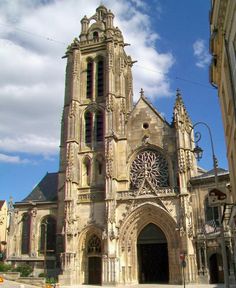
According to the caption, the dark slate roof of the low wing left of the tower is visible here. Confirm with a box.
[21,173,58,202]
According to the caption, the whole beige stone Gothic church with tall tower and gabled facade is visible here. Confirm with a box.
[7,5,232,285]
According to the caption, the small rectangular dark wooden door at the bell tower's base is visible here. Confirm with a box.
[88,257,102,285]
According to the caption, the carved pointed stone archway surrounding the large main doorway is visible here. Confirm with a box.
[119,202,182,284]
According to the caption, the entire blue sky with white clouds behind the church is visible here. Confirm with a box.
[0,0,227,201]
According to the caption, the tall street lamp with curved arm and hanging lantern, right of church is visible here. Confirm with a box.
[190,122,229,288]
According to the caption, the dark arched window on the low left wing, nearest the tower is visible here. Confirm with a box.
[40,216,56,254]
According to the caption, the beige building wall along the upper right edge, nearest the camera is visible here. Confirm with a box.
[210,0,236,202]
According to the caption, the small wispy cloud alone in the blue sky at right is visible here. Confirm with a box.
[193,39,211,68]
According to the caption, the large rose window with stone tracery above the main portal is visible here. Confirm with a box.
[130,150,169,189]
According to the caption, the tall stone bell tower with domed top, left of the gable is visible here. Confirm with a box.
[57,5,133,284]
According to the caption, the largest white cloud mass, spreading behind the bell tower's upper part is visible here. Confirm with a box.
[0,0,174,158]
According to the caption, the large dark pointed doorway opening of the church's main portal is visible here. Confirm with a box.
[137,223,169,284]
